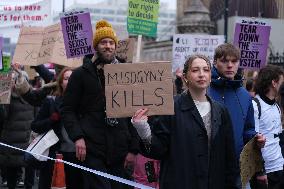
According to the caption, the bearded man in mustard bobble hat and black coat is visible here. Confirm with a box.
[62,20,139,189]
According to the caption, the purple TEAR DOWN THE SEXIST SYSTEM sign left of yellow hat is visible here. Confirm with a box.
[60,12,95,58]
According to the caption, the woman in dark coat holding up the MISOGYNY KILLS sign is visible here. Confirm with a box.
[132,55,237,189]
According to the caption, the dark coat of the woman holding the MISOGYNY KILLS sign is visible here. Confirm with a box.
[141,91,237,189]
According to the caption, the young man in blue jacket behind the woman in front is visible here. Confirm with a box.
[208,43,265,188]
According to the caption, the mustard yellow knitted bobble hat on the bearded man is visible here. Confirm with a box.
[93,20,118,47]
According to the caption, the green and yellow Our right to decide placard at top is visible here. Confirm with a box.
[127,0,160,37]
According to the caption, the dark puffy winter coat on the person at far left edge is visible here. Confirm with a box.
[0,96,34,167]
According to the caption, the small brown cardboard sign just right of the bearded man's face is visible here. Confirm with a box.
[116,38,136,63]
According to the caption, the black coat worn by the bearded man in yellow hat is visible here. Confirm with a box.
[62,57,139,164]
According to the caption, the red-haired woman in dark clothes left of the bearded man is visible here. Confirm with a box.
[31,68,82,189]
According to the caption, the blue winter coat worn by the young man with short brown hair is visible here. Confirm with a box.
[208,67,256,157]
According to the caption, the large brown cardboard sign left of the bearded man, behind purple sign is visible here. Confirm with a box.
[13,24,82,67]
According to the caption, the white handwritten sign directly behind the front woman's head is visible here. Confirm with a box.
[172,34,225,72]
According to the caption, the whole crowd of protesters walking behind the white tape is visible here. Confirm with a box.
[0,20,284,189]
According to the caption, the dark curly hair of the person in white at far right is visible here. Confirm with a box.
[254,65,284,95]
